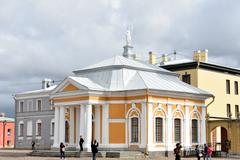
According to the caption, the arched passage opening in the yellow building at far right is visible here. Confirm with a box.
[211,126,228,152]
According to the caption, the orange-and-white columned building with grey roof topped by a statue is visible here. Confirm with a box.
[13,33,212,156]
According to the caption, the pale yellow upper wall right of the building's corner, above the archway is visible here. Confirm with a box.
[198,69,240,118]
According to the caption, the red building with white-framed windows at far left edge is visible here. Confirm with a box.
[0,113,14,148]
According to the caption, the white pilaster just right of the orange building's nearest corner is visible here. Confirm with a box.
[147,103,153,151]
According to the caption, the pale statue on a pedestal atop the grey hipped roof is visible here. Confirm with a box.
[123,27,136,59]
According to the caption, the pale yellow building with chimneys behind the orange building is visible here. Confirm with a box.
[161,50,240,153]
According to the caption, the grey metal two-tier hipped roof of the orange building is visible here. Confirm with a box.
[69,56,211,96]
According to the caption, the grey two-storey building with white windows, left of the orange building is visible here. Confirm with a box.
[14,83,55,149]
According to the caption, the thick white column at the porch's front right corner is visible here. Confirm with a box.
[85,104,92,152]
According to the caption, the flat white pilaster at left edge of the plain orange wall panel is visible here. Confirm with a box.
[102,104,109,147]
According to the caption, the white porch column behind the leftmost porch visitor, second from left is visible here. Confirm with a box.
[59,106,65,143]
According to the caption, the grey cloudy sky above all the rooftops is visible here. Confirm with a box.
[0,0,240,116]
